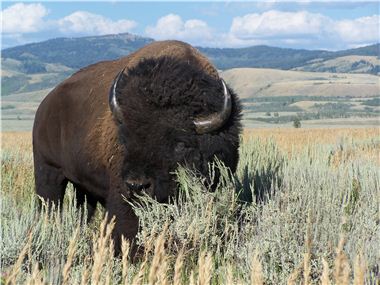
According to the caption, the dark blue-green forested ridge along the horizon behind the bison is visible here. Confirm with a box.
[2,33,380,73]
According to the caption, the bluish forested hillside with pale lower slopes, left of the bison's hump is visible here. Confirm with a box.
[1,33,153,96]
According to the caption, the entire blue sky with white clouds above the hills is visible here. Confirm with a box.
[1,1,380,50]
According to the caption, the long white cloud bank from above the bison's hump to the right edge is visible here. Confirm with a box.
[145,10,380,49]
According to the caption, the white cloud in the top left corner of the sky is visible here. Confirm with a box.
[0,3,49,34]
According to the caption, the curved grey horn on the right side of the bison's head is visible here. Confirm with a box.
[194,79,232,134]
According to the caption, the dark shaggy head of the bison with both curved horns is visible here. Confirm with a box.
[110,57,241,202]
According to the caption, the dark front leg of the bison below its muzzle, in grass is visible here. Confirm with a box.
[106,189,139,257]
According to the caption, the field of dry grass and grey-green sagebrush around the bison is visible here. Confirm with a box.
[0,128,380,284]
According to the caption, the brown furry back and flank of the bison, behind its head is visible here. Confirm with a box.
[33,38,217,186]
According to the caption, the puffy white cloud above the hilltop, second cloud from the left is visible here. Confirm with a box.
[58,11,137,35]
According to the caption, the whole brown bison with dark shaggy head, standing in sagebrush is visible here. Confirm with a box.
[33,41,241,251]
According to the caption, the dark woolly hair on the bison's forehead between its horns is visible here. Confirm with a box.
[114,56,241,134]
